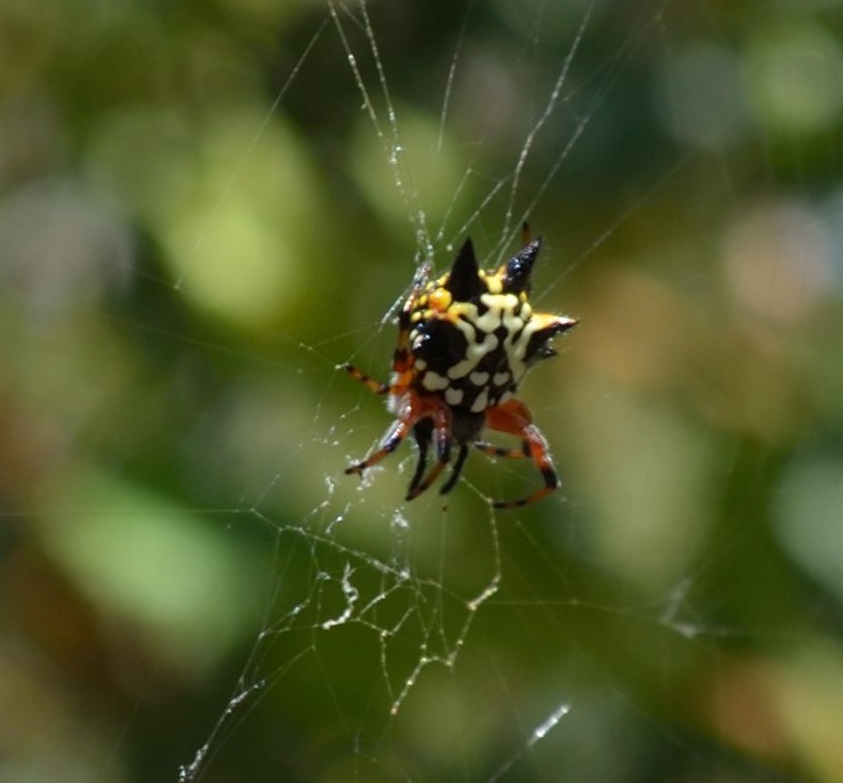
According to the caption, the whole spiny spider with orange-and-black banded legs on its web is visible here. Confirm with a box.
[342,223,577,509]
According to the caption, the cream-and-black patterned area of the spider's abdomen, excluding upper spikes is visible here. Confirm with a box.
[410,293,556,413]
